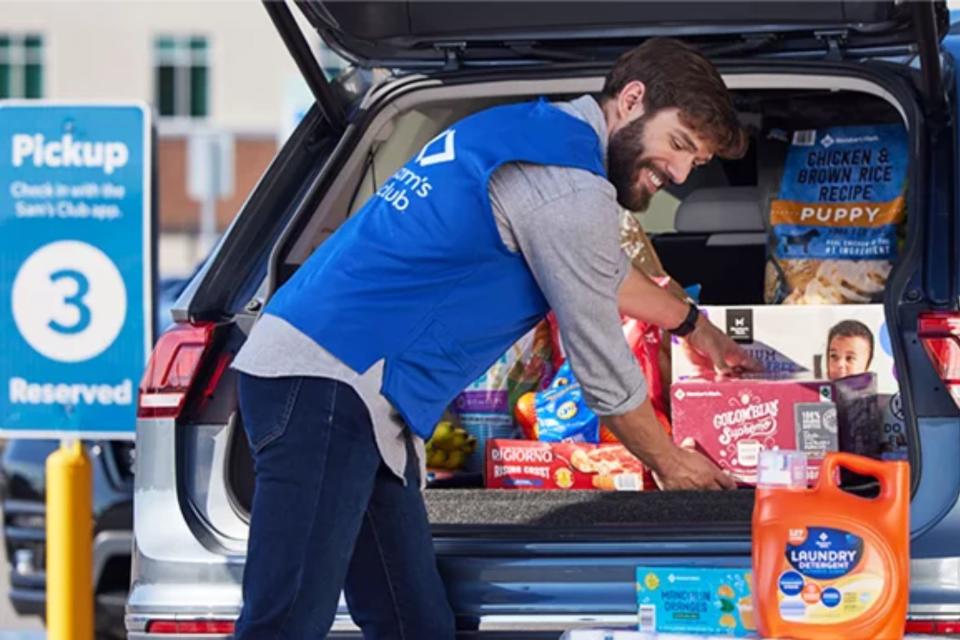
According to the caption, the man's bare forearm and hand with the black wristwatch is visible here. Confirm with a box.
[619,267,763,373]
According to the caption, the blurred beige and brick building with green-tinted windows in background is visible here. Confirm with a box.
[0,0,343,276]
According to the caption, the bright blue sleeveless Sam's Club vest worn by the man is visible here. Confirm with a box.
[265,100,605,438]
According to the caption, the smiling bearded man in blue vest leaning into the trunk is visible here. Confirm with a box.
[233,39,756,640]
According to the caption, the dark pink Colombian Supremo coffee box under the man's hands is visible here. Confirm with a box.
[671,378,838,484]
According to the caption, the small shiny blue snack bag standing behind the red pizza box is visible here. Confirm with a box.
[536,362,600,443]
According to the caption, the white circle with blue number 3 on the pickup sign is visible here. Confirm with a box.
[13,240,127,362]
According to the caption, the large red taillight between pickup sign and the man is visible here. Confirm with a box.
[137,323,213,418]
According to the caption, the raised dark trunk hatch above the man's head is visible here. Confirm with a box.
[297,0,949,68]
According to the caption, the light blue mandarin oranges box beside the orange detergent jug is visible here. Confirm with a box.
[637,567,757,637]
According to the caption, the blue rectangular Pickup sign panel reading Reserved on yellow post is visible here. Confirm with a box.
[0,101,153,438]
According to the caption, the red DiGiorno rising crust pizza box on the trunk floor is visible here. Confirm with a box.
[484,440,652,491]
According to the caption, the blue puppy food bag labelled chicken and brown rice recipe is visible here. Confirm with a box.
[765,125,908,304]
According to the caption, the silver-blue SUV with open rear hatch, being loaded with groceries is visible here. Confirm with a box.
[126,0,960,640]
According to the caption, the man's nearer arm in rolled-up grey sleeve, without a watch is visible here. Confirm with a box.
[491,168,733,489]
